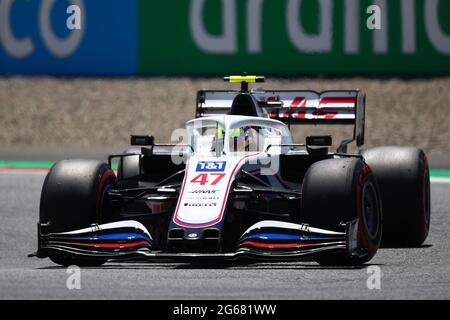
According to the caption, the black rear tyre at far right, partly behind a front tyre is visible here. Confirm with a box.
[361,146,430,247]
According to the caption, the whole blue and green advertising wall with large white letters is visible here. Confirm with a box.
[0,0,450,76]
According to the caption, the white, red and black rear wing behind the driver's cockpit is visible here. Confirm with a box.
[196,90,365,146]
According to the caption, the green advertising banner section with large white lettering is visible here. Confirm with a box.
[139,0,450,75]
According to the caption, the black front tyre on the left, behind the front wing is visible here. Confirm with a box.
[39,160,117,266]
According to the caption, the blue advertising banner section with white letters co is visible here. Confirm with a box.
[0,0,137,75]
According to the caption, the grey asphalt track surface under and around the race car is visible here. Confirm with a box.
[0,172,450,299]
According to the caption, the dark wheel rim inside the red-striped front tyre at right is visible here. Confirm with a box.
[362,182,380,239]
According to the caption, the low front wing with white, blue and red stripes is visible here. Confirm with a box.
[30,220,366,261]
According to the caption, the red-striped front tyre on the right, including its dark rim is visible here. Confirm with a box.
[301,158,382,265]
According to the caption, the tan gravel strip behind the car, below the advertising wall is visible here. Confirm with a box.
[0,77,450,155]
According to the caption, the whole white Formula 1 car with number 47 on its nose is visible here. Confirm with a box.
[32,76,430,265]
